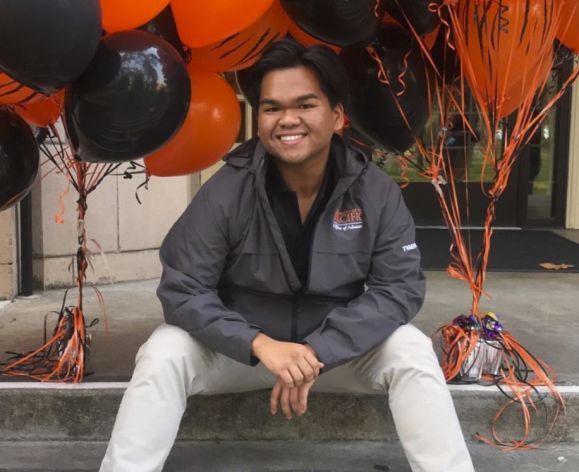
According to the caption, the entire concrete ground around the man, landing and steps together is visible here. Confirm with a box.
[0,272,579,472]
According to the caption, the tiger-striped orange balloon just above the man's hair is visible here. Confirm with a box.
[190,1,290,72]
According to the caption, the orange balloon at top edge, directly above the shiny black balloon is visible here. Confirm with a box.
[101,0,169,33]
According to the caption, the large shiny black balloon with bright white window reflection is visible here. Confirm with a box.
[65,30,191,162]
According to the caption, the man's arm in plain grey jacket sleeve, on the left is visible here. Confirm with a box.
[157,184,260,365]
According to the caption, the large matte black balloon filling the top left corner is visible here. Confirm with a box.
[0,0,102,94]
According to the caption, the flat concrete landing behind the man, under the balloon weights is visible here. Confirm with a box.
[0,272,579,385]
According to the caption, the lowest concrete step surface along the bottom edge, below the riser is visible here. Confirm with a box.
[0,441,579,472]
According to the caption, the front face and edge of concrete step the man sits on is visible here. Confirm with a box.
[0,382,579,444]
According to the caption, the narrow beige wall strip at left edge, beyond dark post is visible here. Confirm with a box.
[0,208,18,300]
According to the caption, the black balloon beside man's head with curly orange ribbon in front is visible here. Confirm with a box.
[340,27,429,153]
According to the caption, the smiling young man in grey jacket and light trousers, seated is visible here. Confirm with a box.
[101,41,473,472]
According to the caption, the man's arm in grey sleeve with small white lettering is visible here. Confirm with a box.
[305,183,426,370]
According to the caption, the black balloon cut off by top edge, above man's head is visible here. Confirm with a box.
[281,0,384,47]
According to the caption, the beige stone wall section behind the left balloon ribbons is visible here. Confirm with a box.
[32,163,199,289]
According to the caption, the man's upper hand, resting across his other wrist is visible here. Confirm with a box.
[251,333,324,388]
